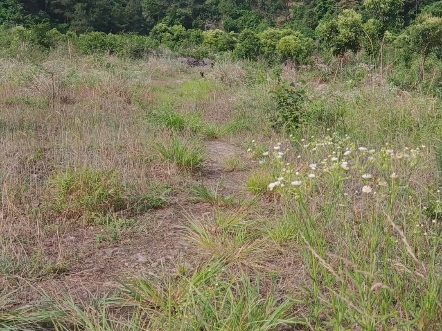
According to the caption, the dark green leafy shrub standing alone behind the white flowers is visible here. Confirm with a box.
[271,83,307,132]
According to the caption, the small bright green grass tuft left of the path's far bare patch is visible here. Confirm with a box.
[158,137,205,170]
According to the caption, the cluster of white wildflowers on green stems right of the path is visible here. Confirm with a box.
[248,135,424,194]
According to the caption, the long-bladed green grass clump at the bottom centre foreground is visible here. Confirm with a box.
[121,263,301,331]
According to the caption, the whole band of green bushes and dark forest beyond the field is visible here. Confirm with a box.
[0,0,442,95]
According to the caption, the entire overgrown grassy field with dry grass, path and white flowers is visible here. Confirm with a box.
[0,52,442,331]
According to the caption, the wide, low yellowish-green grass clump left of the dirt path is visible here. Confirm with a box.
[49,168,126,219]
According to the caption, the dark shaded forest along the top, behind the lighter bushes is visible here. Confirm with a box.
[0,0,442,35]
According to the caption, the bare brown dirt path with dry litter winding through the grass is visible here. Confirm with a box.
[33,140,250,301]
